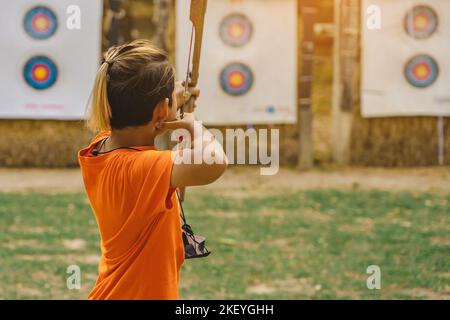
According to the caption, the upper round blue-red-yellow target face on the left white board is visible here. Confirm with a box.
[24,6,58,40]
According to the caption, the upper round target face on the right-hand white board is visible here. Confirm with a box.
[405,6,438,39]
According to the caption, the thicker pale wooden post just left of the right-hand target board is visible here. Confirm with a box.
[333,0,361,165]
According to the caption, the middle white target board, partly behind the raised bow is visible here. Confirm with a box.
[175,0,298,126]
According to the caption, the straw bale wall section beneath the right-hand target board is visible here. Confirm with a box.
[350,109,450,167]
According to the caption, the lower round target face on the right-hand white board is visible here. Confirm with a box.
[405,55,439,88]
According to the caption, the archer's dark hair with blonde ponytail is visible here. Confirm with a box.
[87,40,175,132]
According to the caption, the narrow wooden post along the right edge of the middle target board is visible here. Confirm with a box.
[298,1,317,170]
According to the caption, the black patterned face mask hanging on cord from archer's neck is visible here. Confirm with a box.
[92,138,211,259]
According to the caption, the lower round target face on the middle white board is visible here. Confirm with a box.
[220,63,253,96]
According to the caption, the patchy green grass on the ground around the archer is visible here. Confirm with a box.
[0,190,450,299]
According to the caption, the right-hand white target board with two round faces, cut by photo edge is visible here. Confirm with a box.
[361,0,450,117]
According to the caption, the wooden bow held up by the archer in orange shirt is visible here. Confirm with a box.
[180,0,208,201]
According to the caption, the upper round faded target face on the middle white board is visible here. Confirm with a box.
[220,14,253,47]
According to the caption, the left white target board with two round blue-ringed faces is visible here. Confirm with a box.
[0,0,103,120]
